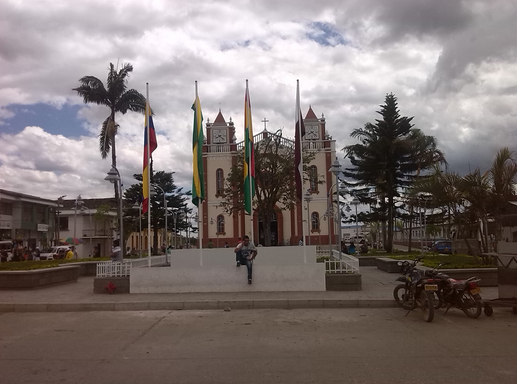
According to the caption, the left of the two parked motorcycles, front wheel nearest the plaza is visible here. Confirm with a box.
[393,258,438,322]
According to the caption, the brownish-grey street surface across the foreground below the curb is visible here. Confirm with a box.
[0,308,517,384]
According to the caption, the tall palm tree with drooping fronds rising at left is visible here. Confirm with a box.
[73,63,146,198]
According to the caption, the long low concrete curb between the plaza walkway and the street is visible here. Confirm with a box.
[0,299,397,313]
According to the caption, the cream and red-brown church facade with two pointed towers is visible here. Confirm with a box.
[200,107,338,248]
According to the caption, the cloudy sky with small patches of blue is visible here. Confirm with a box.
[0,0,517,199]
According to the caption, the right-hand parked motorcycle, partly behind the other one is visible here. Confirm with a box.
[425,264,483,319]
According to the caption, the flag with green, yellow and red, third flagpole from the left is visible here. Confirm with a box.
[244,80,255,215]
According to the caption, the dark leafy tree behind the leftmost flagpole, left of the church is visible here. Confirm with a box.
[124,171,188,250]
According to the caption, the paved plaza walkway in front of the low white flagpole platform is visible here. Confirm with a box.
[0,267,498,312]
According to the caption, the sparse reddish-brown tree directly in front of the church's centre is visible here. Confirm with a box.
[221,131,316,246]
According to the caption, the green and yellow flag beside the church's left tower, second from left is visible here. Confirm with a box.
[192,92,205,207]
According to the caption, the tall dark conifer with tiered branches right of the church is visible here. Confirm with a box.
[343,94,443,252]
